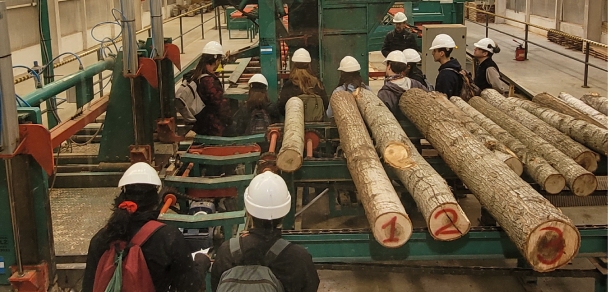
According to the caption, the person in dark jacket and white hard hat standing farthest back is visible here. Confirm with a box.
[381,12,419,57]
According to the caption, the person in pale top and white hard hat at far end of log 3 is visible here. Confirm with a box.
[377,51,428,119]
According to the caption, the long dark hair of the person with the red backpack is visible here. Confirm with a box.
[102,184,160,244]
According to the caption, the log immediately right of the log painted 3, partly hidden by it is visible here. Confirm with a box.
[430,91,523,175]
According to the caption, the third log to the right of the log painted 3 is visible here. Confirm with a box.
[468,96,597,196]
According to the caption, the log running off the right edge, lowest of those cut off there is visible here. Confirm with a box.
[508,97,608,155]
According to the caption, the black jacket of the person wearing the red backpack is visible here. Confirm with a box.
[82,212,210,292]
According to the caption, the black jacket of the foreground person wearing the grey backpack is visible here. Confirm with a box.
[212,228,320,292]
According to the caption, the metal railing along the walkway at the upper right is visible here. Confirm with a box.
[467,8,608,88]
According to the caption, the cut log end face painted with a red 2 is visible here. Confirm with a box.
[428,202,470,241]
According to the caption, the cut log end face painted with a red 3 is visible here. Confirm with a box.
[525,221,580,272]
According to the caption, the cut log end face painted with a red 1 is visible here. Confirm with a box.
[373,212,413,248]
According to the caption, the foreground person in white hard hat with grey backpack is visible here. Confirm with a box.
[212,171,320,292]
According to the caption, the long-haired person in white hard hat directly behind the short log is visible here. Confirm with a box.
[277,48,328,118]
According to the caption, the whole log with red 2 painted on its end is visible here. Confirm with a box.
[354,90,470,241]
